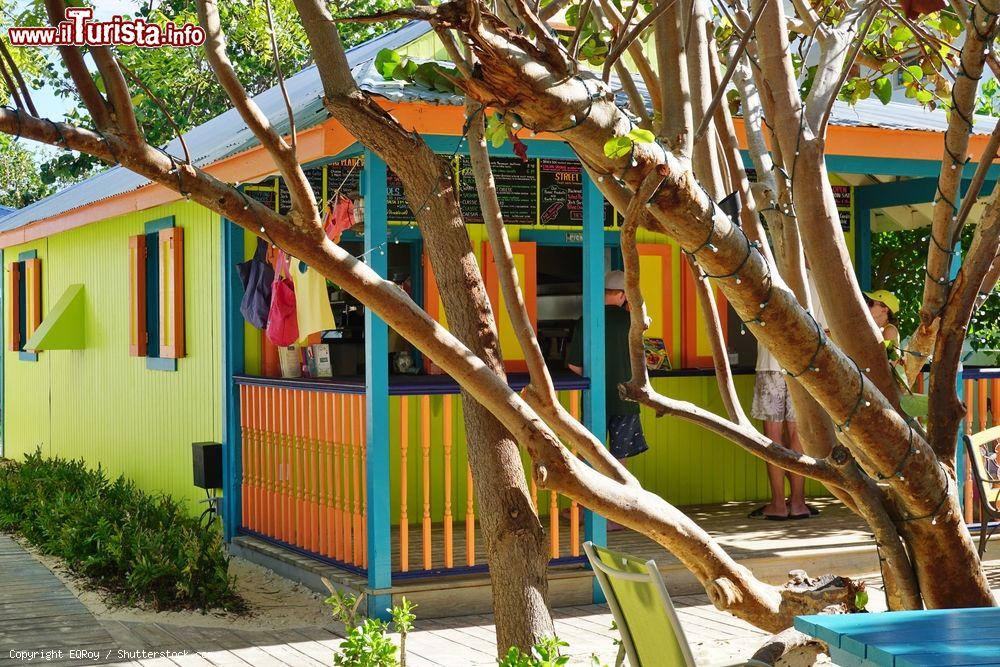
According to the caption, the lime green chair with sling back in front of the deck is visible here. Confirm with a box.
[583,542,764,667]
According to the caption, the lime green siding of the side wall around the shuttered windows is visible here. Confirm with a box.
[3,202,222,511]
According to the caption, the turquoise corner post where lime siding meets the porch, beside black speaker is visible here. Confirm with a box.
[222,218,245,542]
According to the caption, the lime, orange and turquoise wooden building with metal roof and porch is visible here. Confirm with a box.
[0,24,1000,614]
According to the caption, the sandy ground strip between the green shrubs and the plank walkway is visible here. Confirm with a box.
[14,536,333,630]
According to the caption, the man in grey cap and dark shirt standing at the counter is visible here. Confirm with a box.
[566,271,649,498]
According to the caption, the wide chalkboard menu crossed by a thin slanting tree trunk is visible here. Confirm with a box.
[458,156,538,225]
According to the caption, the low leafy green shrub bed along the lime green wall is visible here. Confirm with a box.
[0,453,245,611]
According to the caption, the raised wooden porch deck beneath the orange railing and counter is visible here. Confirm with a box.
[232,499,878,618]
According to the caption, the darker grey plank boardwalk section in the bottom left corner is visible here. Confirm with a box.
[0,535,118,665]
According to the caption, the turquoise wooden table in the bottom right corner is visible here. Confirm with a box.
[795,607,1000,667]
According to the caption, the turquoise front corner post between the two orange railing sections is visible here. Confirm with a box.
[361,151,392,620]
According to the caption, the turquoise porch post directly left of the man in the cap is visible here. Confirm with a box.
[583,173,608,603]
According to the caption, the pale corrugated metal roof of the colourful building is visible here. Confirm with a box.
[0,22,996,232]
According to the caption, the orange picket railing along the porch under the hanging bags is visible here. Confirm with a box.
[238,378,581,576]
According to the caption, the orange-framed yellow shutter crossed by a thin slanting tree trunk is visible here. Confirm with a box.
[483,241,538,373]
